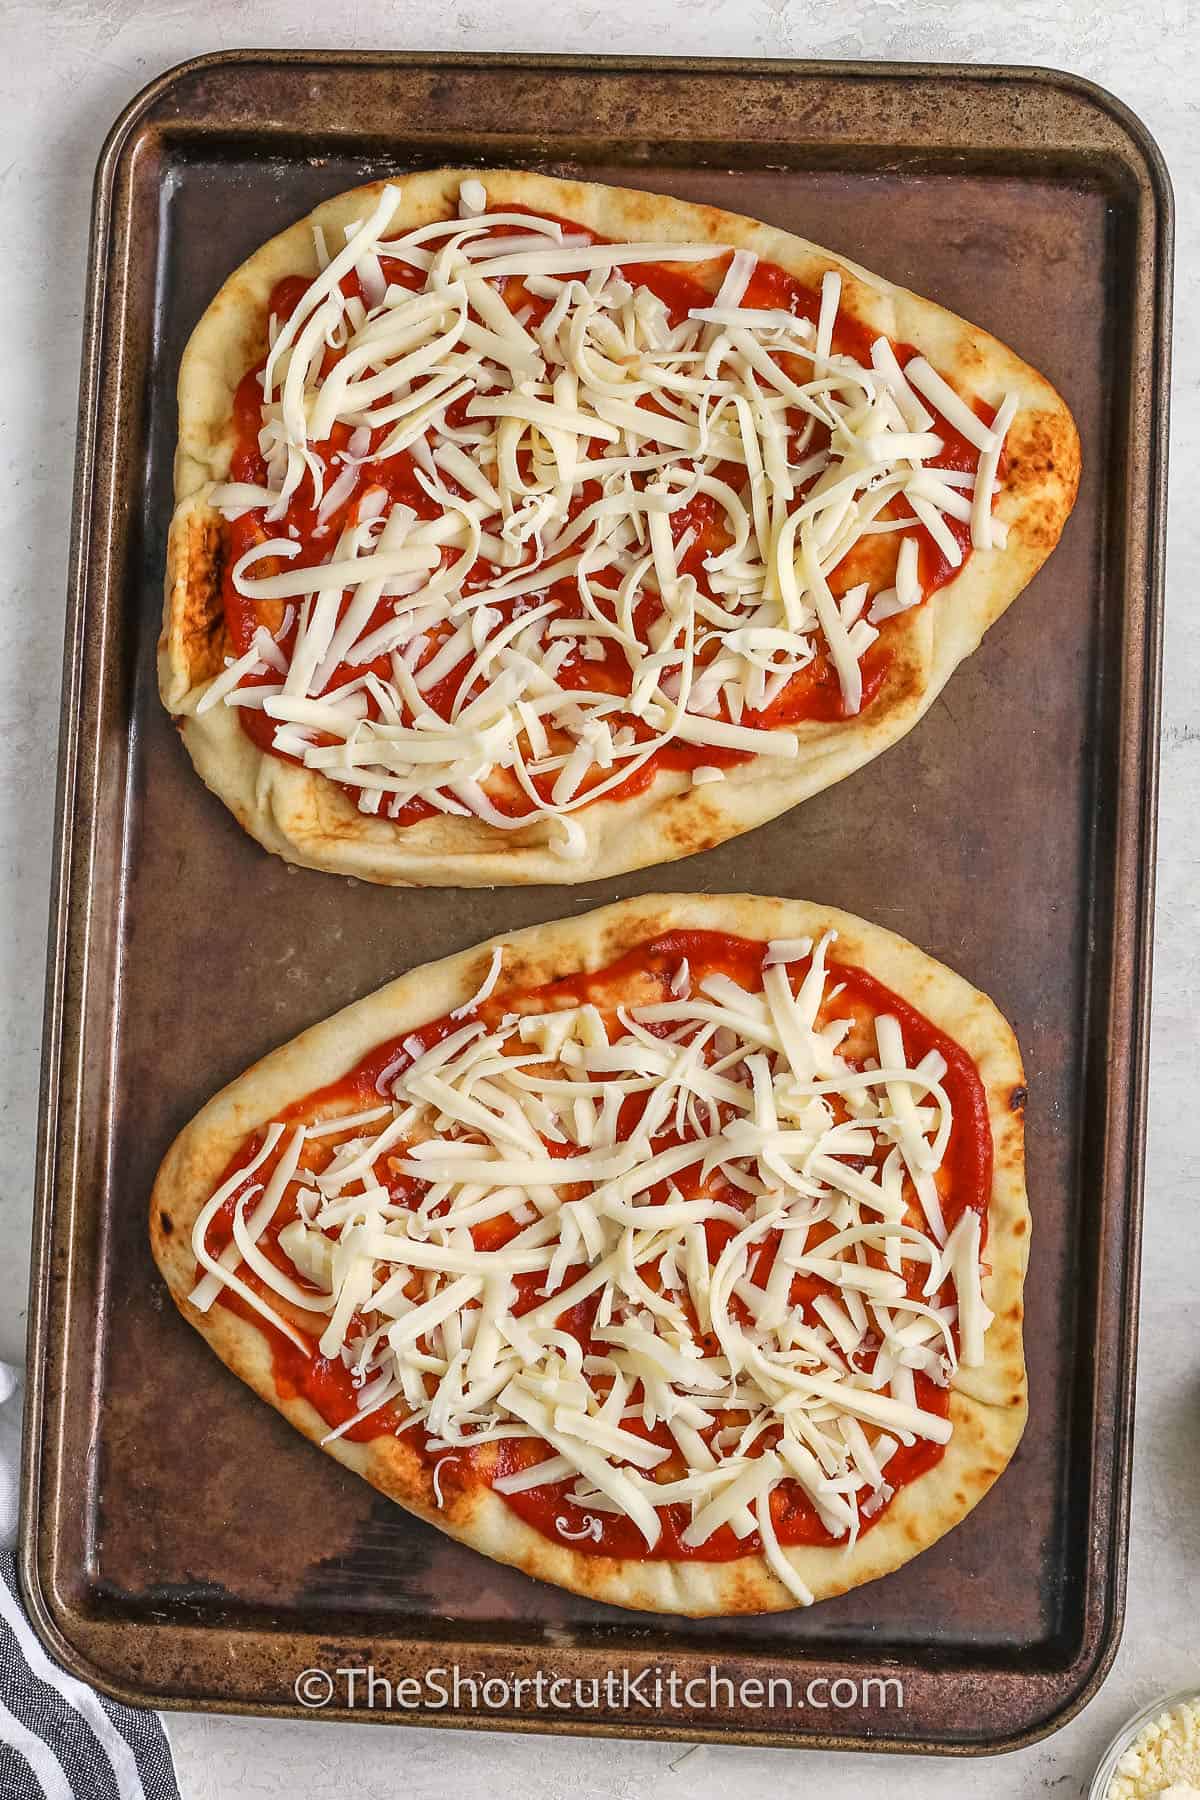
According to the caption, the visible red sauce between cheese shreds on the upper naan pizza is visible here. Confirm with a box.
[223,207,1006,826]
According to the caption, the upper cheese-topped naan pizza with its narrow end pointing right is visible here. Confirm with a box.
[160,171,1079,886]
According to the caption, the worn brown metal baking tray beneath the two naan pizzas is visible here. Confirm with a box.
[22,52,1171,1753]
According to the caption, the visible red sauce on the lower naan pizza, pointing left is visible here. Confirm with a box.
[207,931,991,1562]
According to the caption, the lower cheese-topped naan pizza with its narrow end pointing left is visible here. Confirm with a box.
[151,895,1029,1615]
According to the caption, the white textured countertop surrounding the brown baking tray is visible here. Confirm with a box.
[0,0,1200,1800]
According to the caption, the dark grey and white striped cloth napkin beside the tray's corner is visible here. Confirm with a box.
[0,1363,180,1800]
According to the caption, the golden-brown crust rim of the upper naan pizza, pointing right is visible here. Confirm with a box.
[158,169,1079,887]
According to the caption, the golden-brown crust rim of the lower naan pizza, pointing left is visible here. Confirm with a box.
[149,895,1031,1616]
